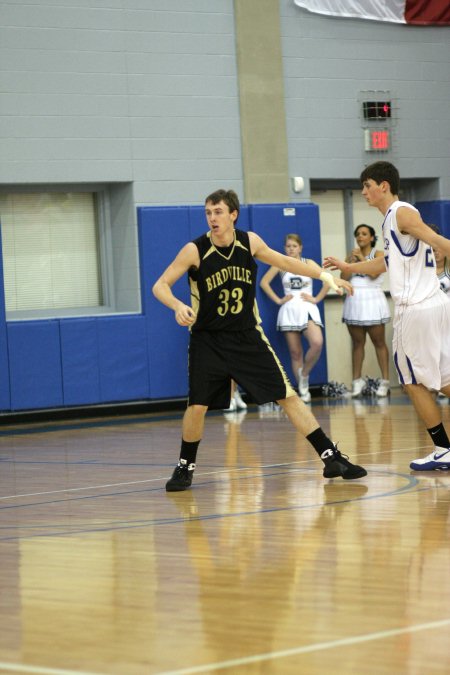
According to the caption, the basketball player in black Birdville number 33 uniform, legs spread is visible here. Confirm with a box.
[153,190,367,492]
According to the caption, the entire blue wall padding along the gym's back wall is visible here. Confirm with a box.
[0,201,450,411]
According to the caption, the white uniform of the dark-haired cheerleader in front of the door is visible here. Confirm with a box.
[342,248,391,326]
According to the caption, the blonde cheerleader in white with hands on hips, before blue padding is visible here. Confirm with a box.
[260,234,329,403]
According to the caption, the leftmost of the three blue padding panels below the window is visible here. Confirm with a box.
[7,320,64,410]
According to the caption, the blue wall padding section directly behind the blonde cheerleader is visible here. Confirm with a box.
[250,204,328,385]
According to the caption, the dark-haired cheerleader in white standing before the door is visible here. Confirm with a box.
[341,224,391,396]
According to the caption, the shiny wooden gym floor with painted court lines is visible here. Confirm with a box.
[0,392,450,675]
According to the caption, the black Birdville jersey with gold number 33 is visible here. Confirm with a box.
[189,230,260,331]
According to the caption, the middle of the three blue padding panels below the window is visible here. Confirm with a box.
[60,319,101,405]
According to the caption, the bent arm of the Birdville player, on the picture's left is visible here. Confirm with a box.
[152,242,200,326]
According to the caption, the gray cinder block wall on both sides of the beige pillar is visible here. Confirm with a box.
[0,0,450,204]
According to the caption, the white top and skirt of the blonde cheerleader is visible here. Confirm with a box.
[277,258,323,333]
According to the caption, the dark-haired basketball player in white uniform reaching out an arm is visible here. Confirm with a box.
[324,162,450,471]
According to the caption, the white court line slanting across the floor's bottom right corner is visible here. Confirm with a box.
[158,618,450,675]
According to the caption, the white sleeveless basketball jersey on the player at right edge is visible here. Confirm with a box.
[383,201,440,305]
